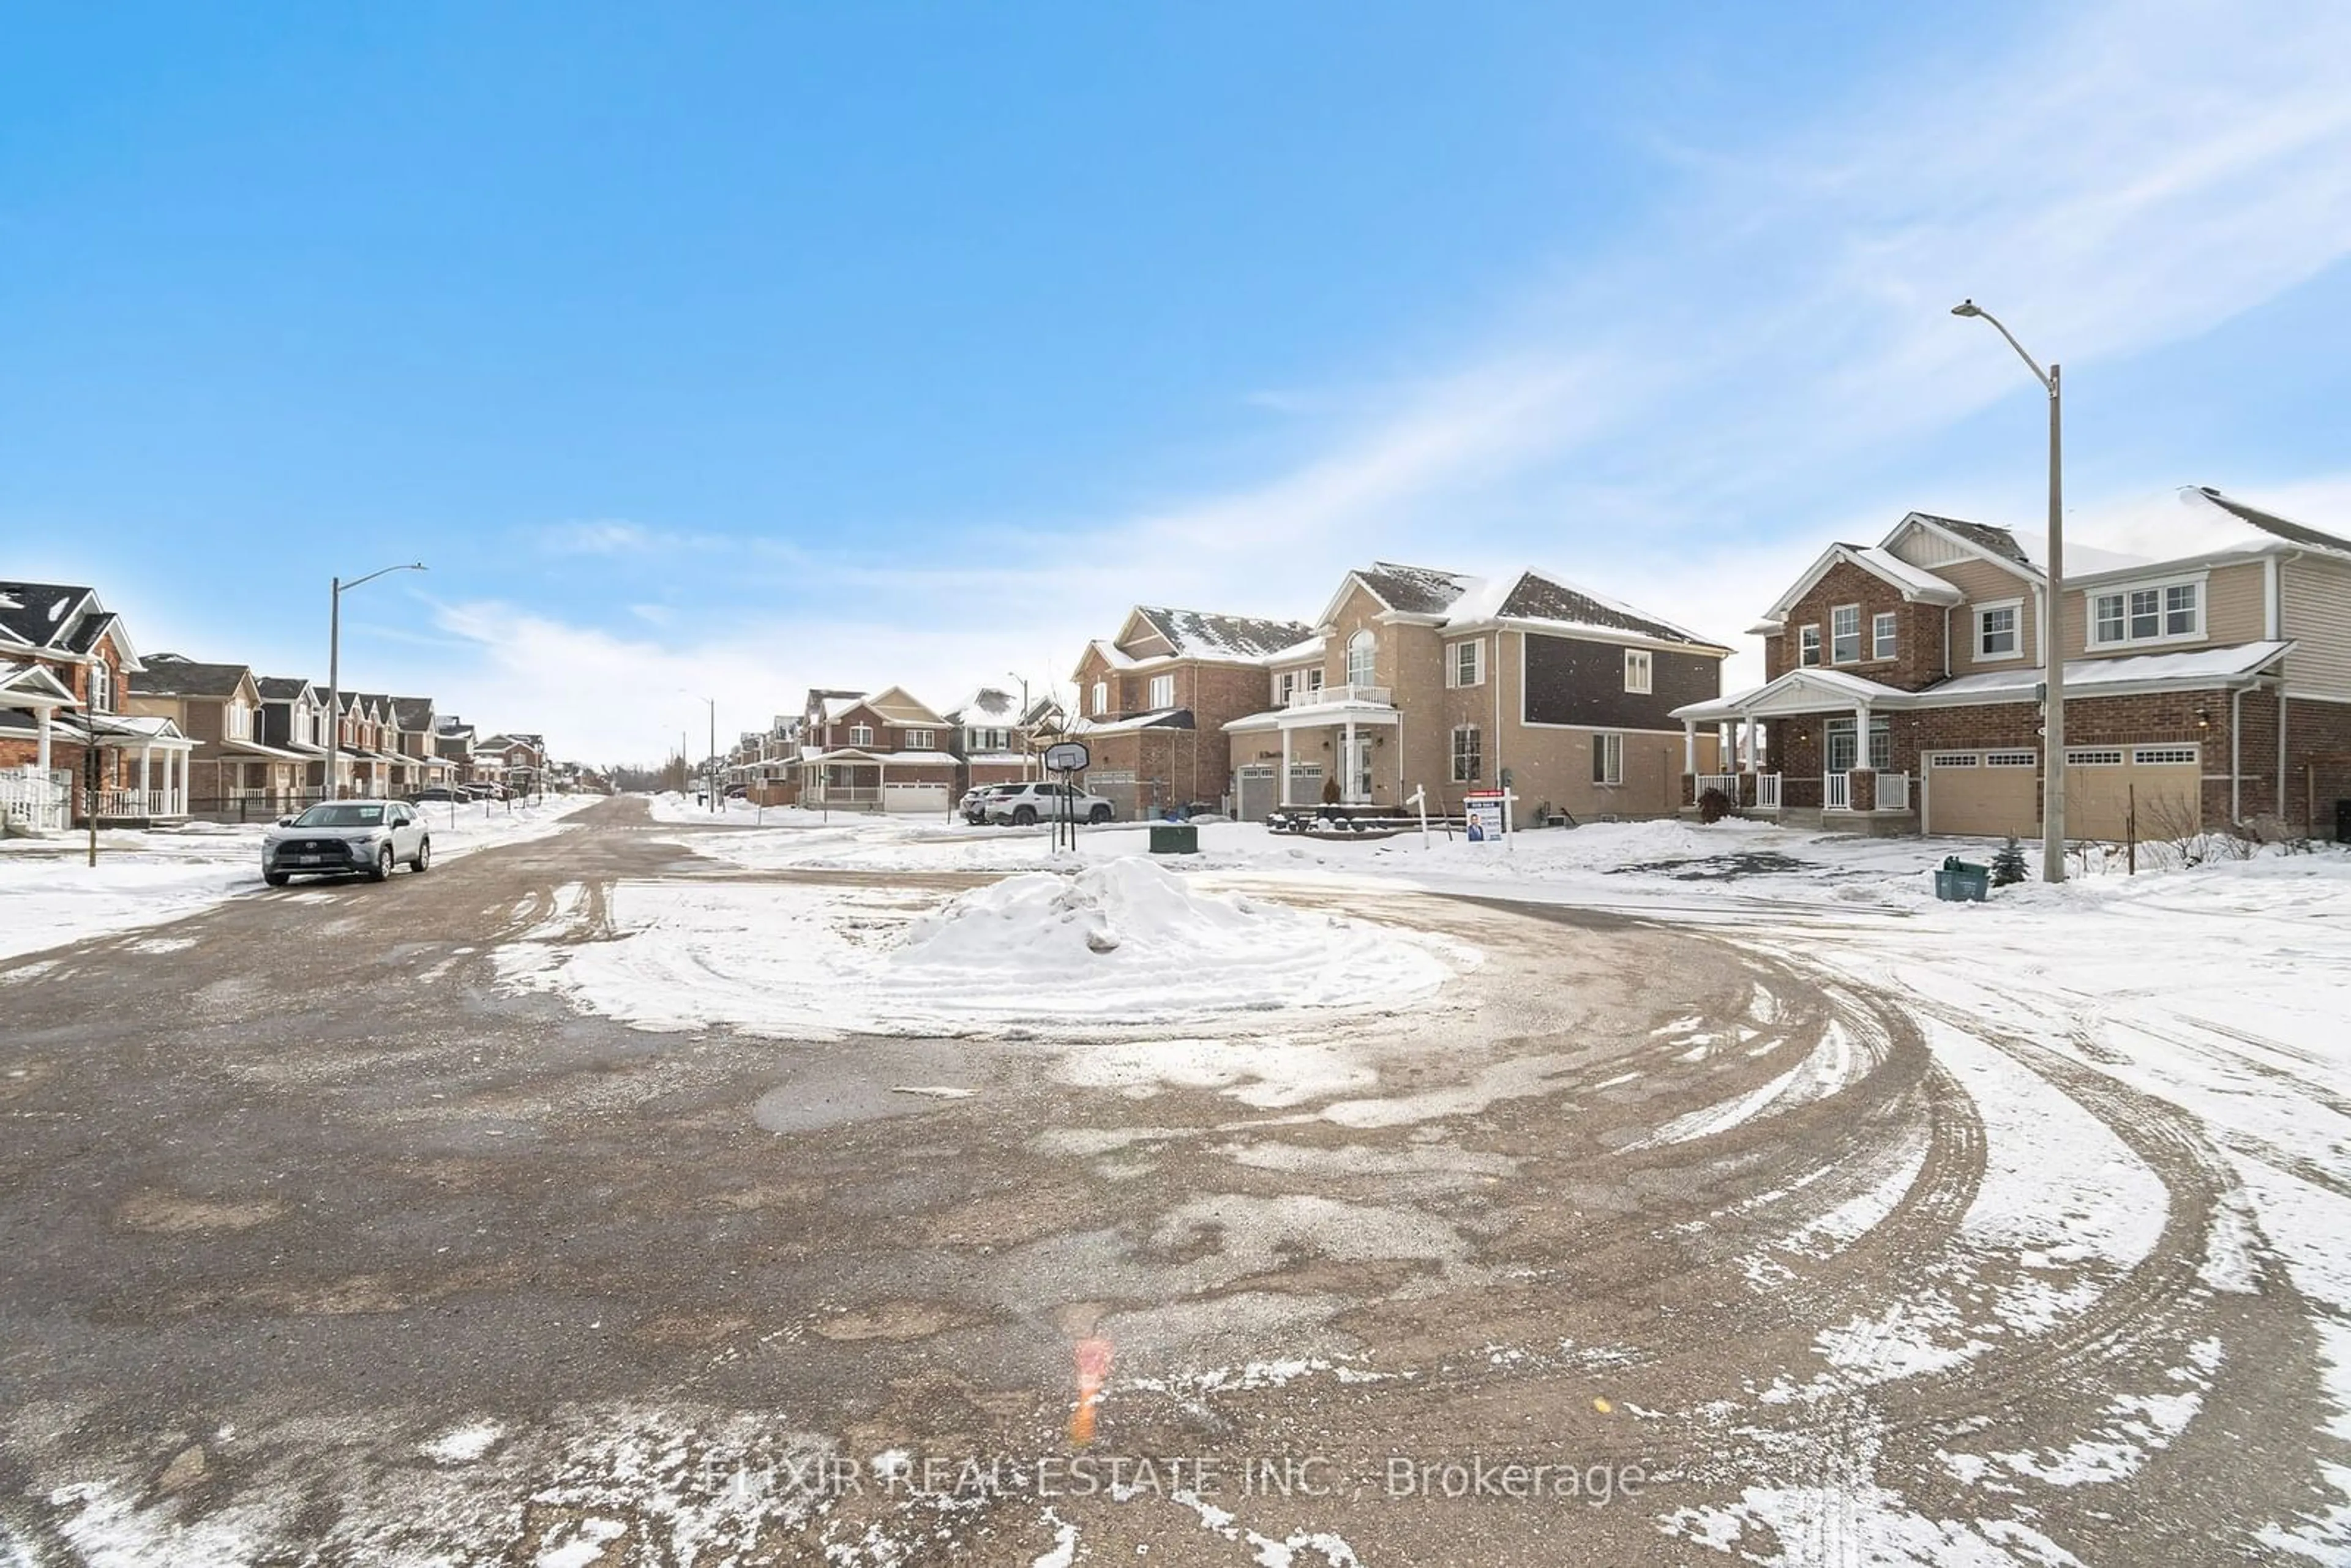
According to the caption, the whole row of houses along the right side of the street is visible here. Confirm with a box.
[729,489,2351,839]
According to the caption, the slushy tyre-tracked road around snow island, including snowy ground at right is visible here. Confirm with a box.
[0,801,2351,1568]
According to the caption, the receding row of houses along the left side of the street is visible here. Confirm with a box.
[0,580,569,830]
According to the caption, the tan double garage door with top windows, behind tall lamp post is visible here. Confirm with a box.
[1921,745,2203,842]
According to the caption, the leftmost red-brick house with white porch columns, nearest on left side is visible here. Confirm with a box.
[0,583,195,828]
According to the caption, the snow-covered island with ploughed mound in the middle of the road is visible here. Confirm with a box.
[498,860,1479,1039]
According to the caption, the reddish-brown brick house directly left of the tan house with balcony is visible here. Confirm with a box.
[1065,604,1314,818]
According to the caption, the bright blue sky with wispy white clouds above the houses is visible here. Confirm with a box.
[0,0,2351,757]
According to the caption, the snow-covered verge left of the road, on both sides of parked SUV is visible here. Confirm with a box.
[0,795,602,959]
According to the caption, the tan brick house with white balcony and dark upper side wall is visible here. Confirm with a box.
[1225,562,1730,818]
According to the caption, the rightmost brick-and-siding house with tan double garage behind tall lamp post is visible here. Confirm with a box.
[1676,491,2351,839]
